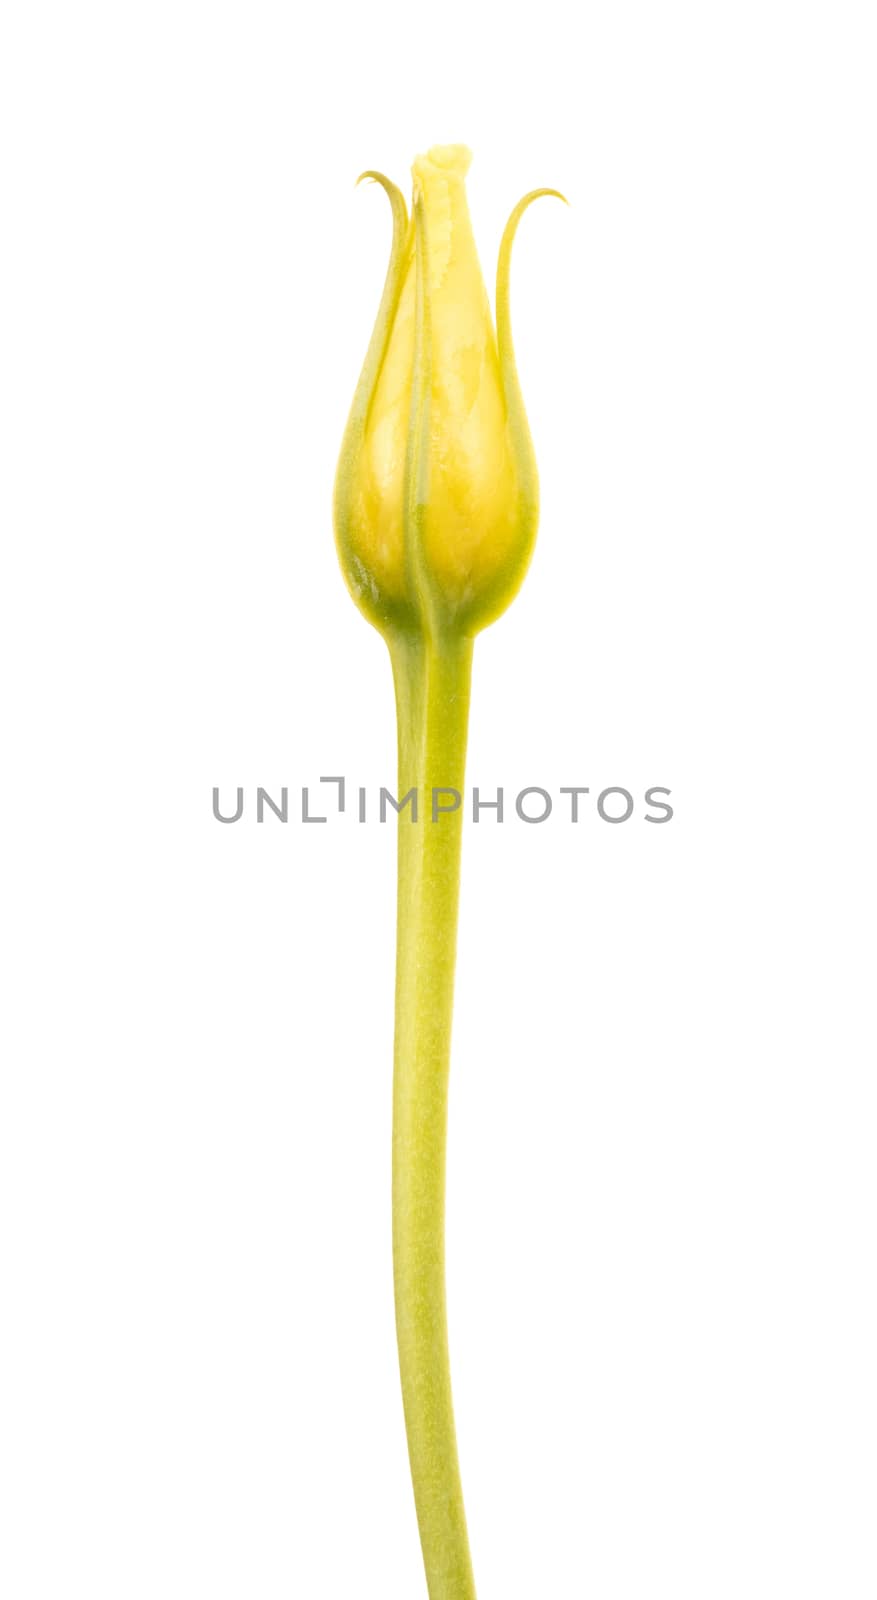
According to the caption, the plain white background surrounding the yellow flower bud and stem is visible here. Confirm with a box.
[0,0,877,1600]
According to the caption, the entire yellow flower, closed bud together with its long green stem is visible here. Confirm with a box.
[334,144,562,1600]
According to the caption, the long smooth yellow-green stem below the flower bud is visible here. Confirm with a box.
[390,634,475,1600]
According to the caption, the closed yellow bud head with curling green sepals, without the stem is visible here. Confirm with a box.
[334,144,562,635]
